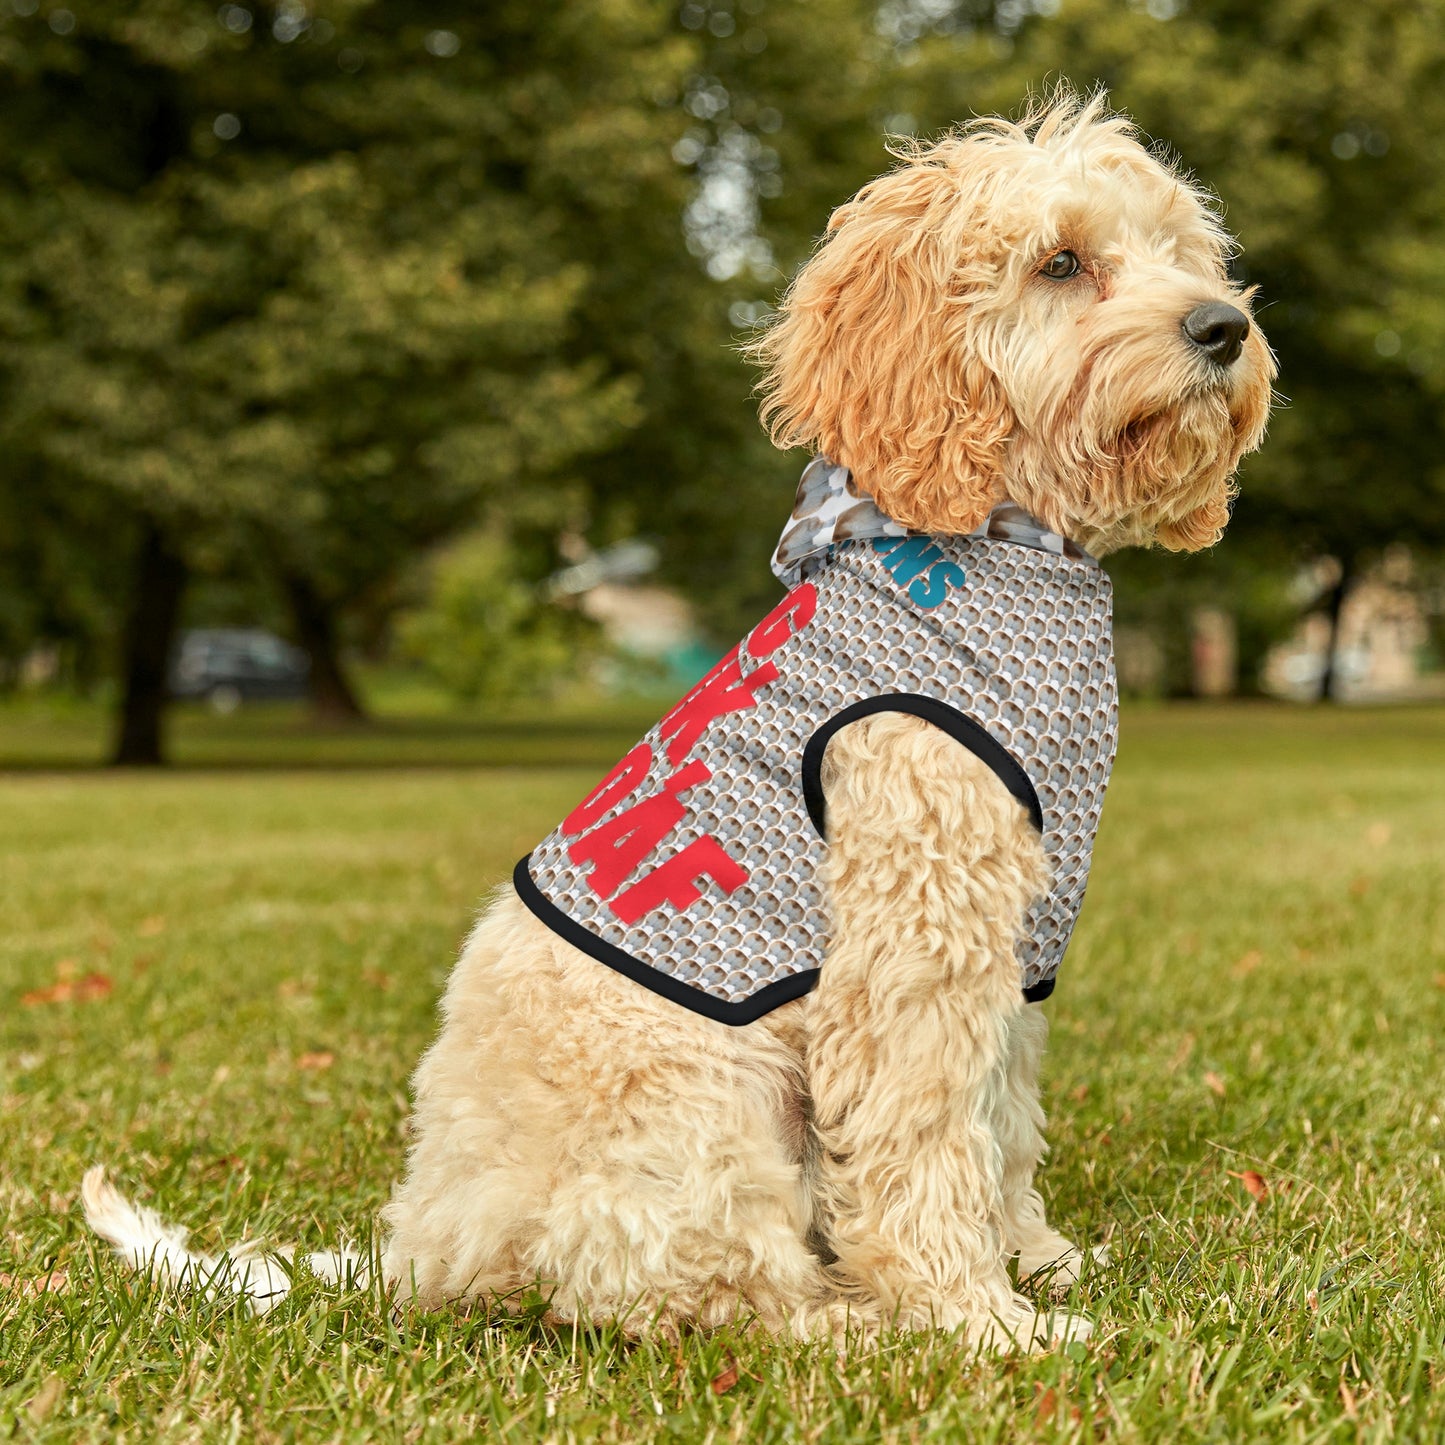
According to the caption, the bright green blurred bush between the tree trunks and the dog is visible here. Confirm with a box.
[397,532,592,702]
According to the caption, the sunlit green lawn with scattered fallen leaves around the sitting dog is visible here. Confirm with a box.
[0,707,1445,1442]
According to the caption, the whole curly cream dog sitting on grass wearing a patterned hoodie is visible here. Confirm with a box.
[87,95,1273,1344]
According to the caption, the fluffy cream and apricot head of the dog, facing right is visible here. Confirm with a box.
[753,92,1274,552]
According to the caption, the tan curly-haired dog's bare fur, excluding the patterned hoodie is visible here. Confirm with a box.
[87,95,1273,1344]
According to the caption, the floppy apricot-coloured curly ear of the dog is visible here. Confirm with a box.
[749,149,1013,533]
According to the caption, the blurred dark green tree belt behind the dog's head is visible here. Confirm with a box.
[0,0,1445,762]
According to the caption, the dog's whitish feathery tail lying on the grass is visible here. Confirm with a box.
[81,1165,370,1315]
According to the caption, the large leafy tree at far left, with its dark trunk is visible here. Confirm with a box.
[0,0,688,763]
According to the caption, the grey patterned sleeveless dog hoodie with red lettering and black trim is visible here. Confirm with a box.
[514,458,1117,1025]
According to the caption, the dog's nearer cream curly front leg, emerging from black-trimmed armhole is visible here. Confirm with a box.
[808,714,1088,1345]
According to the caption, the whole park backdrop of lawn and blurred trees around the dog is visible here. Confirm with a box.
[0,0,1445,1441]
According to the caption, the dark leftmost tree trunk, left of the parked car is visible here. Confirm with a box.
[111,522,186,767]
